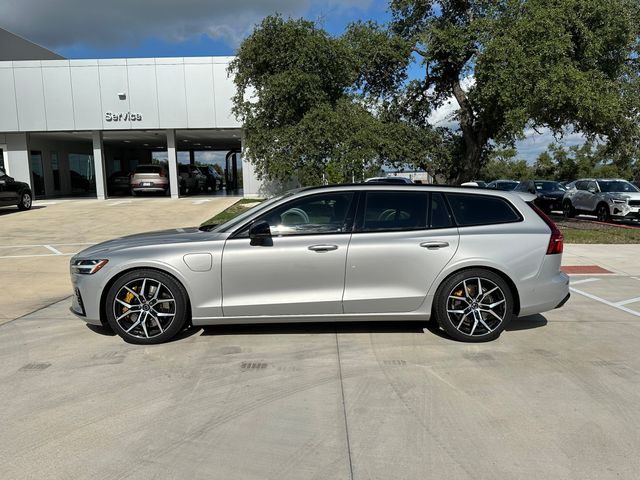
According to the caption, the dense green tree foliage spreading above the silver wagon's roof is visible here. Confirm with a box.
[230,0,640,184]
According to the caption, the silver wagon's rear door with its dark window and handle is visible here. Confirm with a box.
[343,190,459,314]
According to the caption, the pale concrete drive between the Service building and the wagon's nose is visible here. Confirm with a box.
[0,197,238,324]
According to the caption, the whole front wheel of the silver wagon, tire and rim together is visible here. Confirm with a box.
[105,269,188,345]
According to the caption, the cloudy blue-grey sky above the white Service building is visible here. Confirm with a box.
[0,0,371,50]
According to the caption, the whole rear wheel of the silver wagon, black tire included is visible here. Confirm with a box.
[433,268,514,343]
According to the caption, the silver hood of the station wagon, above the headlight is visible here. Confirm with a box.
[75,227,223,258]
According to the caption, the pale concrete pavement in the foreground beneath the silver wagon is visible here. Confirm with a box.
[0,277,640,480]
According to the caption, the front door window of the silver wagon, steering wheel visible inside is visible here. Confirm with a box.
[251,192,353,236]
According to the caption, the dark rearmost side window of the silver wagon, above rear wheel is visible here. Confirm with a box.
[446,193,521,227]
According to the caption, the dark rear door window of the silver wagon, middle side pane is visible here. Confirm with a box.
[359,191,429,232]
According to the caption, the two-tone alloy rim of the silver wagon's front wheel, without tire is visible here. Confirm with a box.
[113,278,176,339]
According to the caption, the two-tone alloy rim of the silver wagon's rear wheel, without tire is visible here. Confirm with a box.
[447,277,507,337]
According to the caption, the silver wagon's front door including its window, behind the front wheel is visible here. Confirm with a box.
[222,191,355,317]
